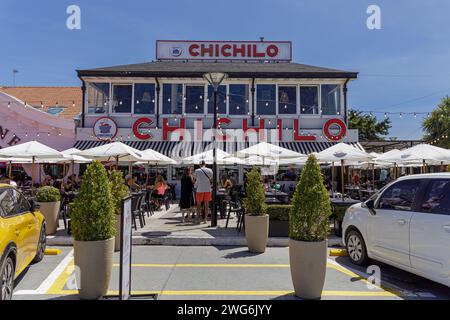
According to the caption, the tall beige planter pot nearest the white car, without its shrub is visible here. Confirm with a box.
[289,239,328,299]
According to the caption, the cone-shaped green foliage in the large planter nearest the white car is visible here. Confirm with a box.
[289,155,331,241]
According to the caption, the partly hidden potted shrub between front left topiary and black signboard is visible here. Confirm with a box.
[109,170,129,251]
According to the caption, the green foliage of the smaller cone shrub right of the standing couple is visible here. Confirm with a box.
[243,167,266,216]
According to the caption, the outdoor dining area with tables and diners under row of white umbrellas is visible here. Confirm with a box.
[0,141,450,236]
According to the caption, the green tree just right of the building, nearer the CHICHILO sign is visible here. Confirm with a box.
[348,110,392,141]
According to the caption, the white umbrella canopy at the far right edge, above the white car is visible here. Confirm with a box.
[382,144,450,164]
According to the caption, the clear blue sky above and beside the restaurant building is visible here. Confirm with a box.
[0,0,450,139]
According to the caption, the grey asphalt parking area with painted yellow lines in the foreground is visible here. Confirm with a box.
[13,246,450,300]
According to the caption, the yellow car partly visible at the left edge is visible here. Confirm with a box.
[0,184,46,300]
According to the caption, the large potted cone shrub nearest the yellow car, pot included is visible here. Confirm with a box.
[70,161,115,300]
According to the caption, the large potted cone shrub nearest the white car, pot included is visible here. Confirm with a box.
[289,155,331,299]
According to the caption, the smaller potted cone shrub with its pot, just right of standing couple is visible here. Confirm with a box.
[243,167,269,253]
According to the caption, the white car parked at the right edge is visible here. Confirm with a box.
[342,173,450,287]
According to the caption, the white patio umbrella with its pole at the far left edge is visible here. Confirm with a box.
[0,141,63,195]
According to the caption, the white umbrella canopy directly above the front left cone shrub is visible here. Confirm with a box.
[75,142,144,162]
